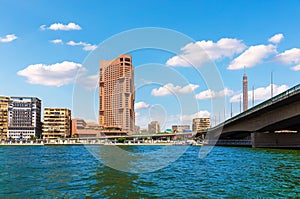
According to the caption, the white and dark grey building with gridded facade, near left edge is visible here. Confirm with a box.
[8,97,42,139]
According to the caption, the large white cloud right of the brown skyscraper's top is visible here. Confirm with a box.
[166,38,246,66]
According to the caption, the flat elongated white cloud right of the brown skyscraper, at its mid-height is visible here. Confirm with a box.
[151,83,199,96]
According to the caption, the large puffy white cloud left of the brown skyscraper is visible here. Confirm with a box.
[17,61,86,87]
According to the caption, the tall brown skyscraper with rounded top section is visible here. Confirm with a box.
[98,54,135,134]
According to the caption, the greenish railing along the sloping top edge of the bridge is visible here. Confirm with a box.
[212,84,300,129]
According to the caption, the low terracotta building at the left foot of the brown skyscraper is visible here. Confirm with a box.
[72,118,102,138]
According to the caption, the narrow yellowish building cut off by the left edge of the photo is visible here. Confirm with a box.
[0,96,10,140]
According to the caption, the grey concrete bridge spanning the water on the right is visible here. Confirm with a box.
[202,84,300,148]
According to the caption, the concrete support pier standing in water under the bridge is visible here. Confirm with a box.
[251,131,300,148]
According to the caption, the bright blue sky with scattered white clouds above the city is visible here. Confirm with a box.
[0,0,300,130]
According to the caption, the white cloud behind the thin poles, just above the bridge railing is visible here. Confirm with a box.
[230,84,289,102]
